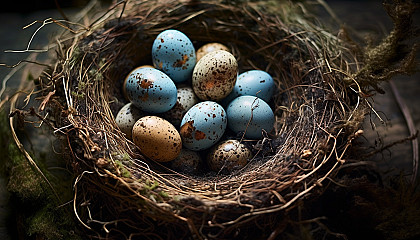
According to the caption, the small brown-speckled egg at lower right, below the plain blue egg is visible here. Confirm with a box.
[206,140,252,172]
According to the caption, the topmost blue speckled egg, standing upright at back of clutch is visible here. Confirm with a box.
[152,29,197,83]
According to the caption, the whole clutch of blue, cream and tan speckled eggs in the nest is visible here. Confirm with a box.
[116,29,275,173]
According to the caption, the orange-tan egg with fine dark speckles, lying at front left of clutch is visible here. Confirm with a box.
[133,116,182,162]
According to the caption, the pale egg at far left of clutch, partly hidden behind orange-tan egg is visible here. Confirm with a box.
[115,103,144,139]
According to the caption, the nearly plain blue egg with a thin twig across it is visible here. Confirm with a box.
[226,96,274,139]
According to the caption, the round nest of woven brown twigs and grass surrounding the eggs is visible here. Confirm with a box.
[32,1,376,239]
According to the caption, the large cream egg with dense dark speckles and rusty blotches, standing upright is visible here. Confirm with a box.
[192,50,238,101]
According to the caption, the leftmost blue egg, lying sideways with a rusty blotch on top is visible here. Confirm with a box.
[125,68,177,113]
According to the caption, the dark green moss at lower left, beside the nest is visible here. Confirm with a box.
[0,110,82,240]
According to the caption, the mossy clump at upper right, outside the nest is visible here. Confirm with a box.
[347,0,420,93]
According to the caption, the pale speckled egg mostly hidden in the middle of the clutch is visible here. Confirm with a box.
[162,86,199,126]
